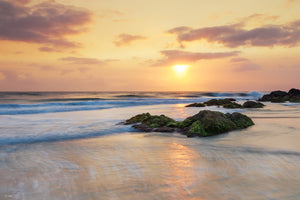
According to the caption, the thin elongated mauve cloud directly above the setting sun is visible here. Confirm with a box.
[152,50,239,66]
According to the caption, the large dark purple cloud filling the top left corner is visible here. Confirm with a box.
[0,0,91,48]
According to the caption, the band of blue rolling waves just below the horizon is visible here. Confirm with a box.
[0,92,262,115]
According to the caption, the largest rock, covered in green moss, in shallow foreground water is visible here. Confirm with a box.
[124,110,254,137]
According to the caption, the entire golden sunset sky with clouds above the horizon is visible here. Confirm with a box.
[0,0,300,91]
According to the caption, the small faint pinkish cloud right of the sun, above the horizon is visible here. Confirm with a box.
[230,57,262,72]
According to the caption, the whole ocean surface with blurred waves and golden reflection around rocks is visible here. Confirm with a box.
[0,91,300,200]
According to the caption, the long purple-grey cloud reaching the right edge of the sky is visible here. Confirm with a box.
[168,16,300,48]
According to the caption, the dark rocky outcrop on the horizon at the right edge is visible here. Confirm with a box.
[259,88,300,103]
